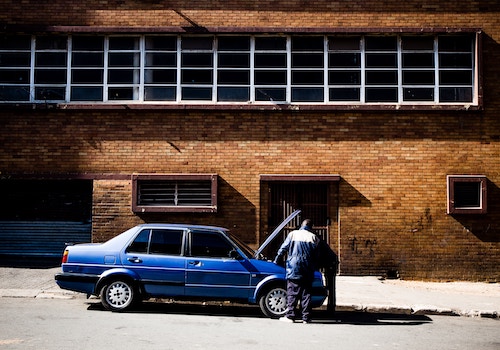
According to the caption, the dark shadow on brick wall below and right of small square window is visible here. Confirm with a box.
[451,180,500,242]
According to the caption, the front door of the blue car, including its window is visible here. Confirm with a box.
[185,229,250,299]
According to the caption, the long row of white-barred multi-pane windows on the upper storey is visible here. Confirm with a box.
[0,34,477,104]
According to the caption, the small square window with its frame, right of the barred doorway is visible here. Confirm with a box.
[447,175,487,214]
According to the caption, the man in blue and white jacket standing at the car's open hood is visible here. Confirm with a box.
[274,219,320,323]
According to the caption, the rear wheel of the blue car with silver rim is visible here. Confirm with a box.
[101,279,136,311]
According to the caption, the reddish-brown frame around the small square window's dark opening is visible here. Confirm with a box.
[446,175,488,214]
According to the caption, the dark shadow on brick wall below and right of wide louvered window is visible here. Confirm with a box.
[136,176,257,244]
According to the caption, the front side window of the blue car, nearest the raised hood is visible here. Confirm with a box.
[191,231,234,258]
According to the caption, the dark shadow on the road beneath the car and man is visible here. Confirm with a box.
[88,301,432,326]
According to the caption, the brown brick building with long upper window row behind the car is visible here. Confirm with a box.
[0,0,500,281]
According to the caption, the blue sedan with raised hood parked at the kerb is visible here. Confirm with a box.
[55,211,327,318]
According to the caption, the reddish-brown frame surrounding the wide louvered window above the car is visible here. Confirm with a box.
[132,174,218,214]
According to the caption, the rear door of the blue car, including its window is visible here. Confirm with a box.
[122,228,186,297]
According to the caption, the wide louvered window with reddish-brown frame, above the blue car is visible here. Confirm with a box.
[132,174,217,213]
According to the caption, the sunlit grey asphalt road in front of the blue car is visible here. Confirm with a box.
[0,298,500,350]
